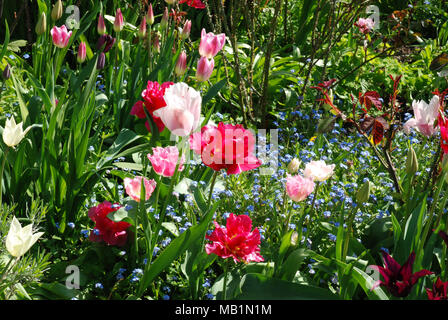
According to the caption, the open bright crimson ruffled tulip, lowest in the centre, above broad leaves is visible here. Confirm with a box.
[205,213,264,263]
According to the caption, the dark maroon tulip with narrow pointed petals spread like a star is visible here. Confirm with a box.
[371,250,432,297]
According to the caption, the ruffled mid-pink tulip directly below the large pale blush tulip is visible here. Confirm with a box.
[148,146,185,177]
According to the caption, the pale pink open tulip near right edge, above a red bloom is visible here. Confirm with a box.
[403,96,439,138]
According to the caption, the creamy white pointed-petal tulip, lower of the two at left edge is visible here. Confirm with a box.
[6,217,44,258]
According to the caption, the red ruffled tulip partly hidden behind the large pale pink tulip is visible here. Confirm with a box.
[131,81,174,132]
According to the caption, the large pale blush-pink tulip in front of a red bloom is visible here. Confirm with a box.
[154,82,202,137]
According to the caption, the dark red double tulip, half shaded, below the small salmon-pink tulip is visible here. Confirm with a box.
[89,201,131,247]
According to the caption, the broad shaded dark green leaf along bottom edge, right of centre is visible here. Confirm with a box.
[236,273,339,300]
